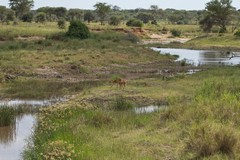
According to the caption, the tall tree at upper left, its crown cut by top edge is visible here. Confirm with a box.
[9,0,34,19]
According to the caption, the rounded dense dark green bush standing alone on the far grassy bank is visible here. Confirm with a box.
[66,20,90,39]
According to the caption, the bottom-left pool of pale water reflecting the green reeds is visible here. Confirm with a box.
[0,114,35,160]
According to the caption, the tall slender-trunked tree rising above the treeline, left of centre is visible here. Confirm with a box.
[94,2,111,25]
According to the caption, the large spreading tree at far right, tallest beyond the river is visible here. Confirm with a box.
[200,0,234,32]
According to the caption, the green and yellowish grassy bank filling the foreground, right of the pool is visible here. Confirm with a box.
[25,67,240,159]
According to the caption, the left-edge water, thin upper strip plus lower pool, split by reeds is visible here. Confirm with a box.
[0,99,65,160]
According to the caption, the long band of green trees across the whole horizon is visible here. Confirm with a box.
[0,0,240,33]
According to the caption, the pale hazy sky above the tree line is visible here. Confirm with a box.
[0,0,240,10]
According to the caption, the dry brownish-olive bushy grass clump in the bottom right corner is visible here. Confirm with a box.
[186,123,238,158]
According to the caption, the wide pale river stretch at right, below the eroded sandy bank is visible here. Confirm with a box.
[152,48,240,66]
